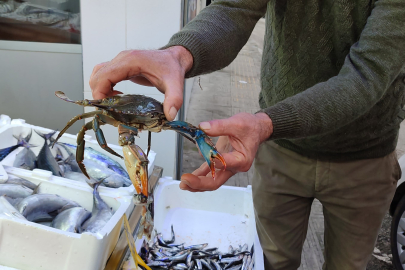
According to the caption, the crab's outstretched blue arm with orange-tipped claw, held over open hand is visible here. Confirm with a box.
[163,121,226,179]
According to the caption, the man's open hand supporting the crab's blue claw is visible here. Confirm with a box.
[180,113,273,192]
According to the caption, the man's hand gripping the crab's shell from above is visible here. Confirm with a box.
[89,46,193,121]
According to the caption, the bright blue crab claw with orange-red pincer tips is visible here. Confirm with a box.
[195,129,226,179]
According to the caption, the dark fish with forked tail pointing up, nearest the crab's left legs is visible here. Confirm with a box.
[35,130,64,177]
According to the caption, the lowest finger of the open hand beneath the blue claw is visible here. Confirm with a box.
[181,171,235,191]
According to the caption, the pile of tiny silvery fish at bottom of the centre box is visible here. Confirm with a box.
[139,226,254,270]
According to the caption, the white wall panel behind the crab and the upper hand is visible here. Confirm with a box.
[80,0,181,176]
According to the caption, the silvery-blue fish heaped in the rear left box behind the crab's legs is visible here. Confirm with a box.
[0,130,132,188]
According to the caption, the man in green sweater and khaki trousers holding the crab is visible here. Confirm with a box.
[90,0,405,270]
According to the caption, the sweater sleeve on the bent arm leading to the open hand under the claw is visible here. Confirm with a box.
[261,0,405,139]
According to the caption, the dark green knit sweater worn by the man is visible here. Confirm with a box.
[166,0,405,161]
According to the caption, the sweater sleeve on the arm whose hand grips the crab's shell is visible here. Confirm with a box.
[163,0,268,78]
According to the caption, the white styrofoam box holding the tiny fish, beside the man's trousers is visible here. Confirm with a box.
[145,178,264,270]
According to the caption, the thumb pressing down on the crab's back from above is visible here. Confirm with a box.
[163,77,184,121]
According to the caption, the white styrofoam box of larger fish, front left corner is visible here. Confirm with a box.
[0,170,132,270]
